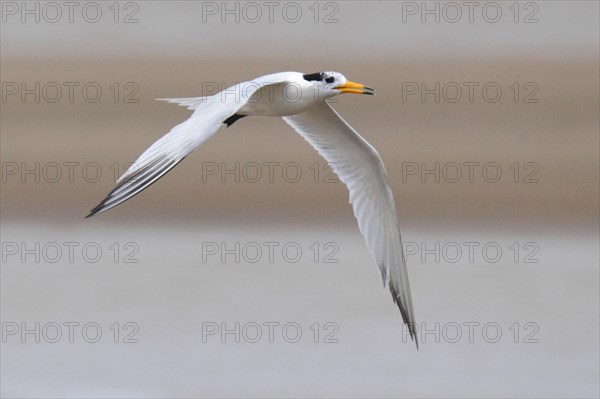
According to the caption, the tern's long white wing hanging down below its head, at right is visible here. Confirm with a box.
[283,103,418,347]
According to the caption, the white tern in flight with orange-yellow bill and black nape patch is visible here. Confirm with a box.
[86,71,418,347]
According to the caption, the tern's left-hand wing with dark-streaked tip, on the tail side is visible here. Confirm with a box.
[86,73,290,217]
